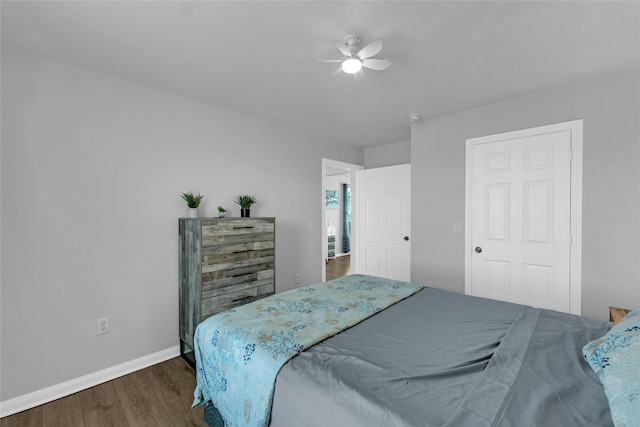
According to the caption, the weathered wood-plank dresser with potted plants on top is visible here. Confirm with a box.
[178,218,276,365]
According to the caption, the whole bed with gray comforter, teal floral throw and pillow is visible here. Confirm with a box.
[194,275,640,427]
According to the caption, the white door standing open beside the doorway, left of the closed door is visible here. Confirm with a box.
[353,165,411,281]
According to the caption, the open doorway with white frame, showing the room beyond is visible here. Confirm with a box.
[321,159,364,282]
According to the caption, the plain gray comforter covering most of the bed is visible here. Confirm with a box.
[271,288,612,427]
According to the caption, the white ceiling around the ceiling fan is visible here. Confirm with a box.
[1,1,640,147]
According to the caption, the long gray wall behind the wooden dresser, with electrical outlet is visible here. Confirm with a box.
[0,47,363,401]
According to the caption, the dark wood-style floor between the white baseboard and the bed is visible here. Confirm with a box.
[0,357,207,427]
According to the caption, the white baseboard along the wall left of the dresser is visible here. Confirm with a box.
[0,346,180,418]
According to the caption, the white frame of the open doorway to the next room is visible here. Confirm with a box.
[319,158,364,282]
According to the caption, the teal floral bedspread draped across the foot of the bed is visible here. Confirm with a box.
[193,275,423,426]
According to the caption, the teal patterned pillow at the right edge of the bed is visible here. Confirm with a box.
[582,307,640,427]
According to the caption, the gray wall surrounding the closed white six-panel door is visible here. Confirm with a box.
[411,73,640,320]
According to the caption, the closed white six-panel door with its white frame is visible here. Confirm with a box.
[465,120,580,314]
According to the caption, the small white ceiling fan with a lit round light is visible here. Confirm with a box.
[314,34,391,80]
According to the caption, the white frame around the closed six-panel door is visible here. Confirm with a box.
[464,119,583,315]
